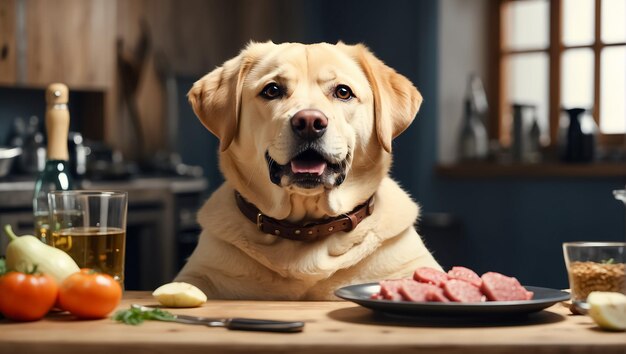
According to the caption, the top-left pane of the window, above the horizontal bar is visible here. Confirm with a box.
[503,0,550,49]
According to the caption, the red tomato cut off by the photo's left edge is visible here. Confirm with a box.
[0,272,58,321]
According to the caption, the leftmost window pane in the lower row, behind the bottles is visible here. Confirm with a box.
[503,53,549,139]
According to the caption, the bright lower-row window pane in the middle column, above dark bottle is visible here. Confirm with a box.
[561,48,593,108]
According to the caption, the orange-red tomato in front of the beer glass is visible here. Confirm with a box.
[59,269,122,318]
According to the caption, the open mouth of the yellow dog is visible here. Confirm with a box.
[265,148,347,189]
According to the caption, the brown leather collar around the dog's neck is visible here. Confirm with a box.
[235,191,374,241]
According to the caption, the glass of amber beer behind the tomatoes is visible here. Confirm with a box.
[48,190,128,286]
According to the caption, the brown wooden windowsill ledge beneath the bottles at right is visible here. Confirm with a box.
[436,162,626,179]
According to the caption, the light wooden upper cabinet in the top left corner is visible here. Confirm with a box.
[0,0,117,90]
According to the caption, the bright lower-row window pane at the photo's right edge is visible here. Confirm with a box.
[600,46,626,134]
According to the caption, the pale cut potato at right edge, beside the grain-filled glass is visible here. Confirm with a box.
[587,291,626,331]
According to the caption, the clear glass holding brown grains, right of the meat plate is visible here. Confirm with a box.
[563,242,626,301]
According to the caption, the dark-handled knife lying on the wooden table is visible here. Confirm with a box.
[131,304,304,333]
